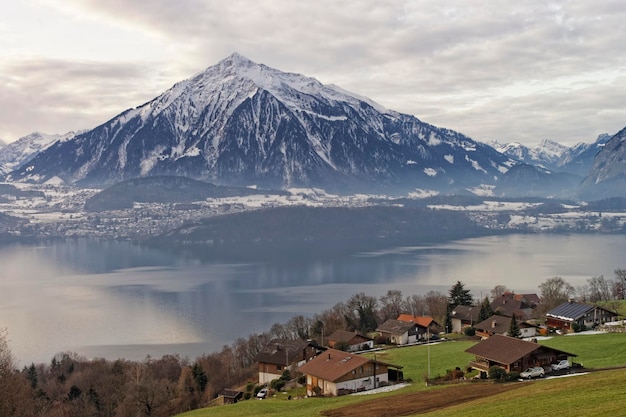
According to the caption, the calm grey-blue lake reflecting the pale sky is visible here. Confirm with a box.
[0,234,626,365]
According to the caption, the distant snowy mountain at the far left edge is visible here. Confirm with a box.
[0,132,76,174]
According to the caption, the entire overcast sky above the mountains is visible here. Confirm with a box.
[0,0,626,145]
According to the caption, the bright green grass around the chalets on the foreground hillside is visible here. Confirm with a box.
[180,333,626,417]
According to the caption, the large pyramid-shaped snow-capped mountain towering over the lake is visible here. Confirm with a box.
[9,54,515,192]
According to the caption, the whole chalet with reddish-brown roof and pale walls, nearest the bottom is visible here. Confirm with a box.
[297,349,402,396]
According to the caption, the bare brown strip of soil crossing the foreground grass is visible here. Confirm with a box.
[322,383,523,417]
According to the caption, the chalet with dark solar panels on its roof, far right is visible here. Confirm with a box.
[546,301,617,332]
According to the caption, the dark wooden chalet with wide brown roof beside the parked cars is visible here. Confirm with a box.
[465,334,576,373]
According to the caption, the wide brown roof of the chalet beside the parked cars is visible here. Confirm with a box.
[465,334,576,365]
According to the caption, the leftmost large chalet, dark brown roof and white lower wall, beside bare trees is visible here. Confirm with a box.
[256,339,318,384]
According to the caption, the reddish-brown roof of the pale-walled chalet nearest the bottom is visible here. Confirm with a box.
[298,349,371,382]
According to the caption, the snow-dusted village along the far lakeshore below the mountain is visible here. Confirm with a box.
[0,184,626,239]
